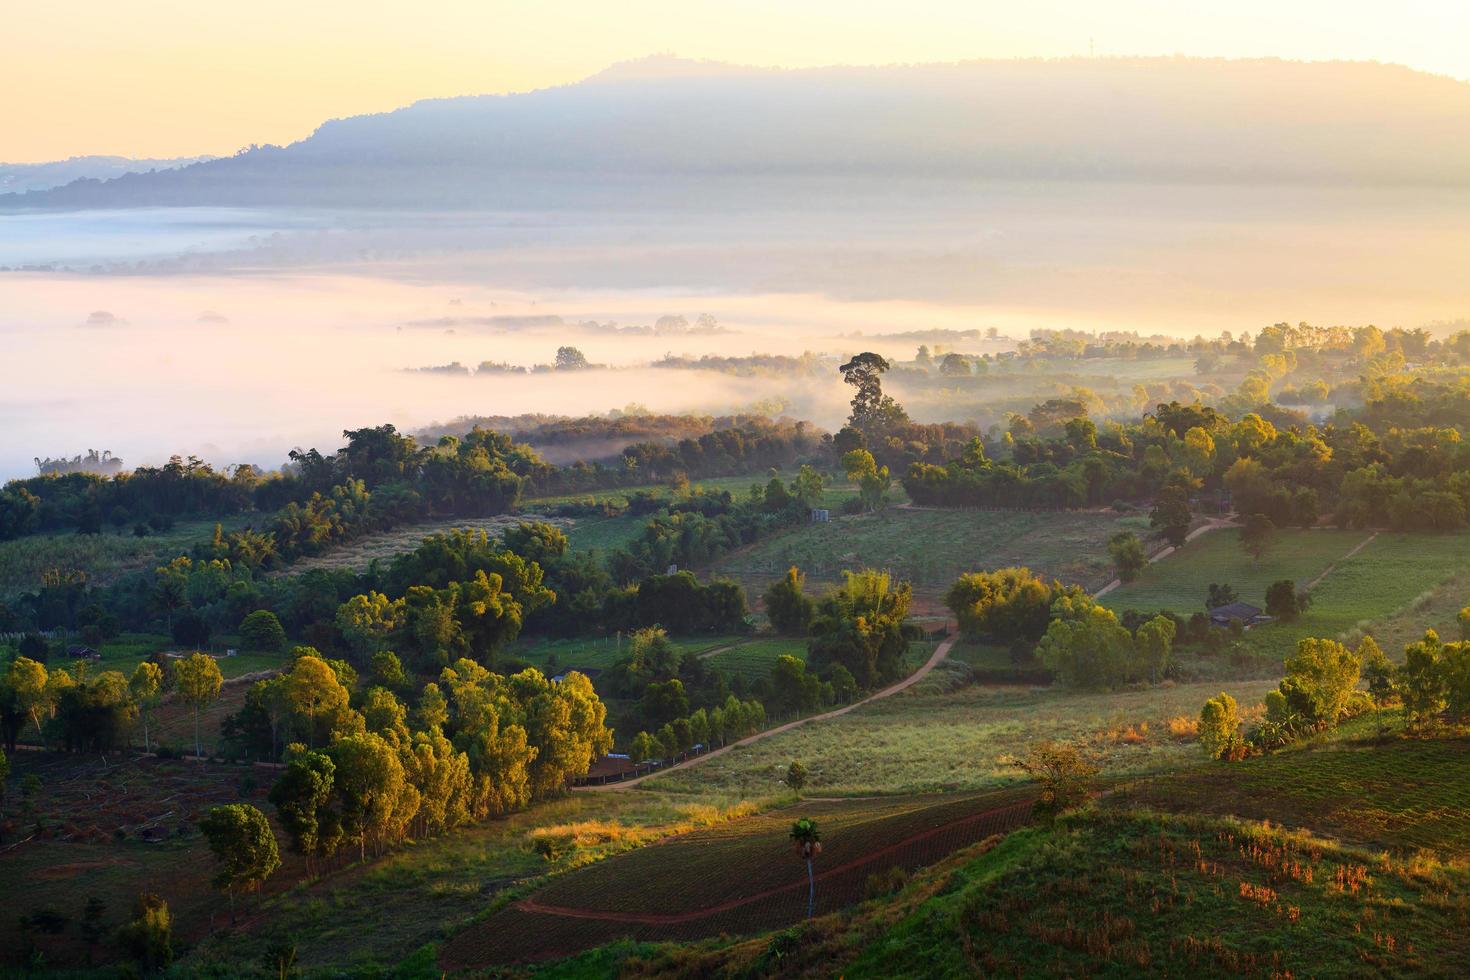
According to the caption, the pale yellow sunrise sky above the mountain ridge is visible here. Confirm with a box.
[0,0,1470,163]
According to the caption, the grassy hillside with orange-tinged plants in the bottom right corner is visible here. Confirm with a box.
[842,813,1470,977]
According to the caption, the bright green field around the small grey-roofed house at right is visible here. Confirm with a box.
[1103,530,1470,666]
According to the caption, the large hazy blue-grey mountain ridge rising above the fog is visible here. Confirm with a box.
[11,57,1470,209]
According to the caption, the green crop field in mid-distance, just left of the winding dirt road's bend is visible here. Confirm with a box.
[711,507,1147,595]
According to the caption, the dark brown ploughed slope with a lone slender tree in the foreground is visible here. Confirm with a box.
[440,793,1030,970]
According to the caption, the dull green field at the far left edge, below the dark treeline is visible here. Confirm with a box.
[0,514,252,601]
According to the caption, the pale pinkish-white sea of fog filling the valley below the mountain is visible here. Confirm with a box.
[0,182,1470,478]
